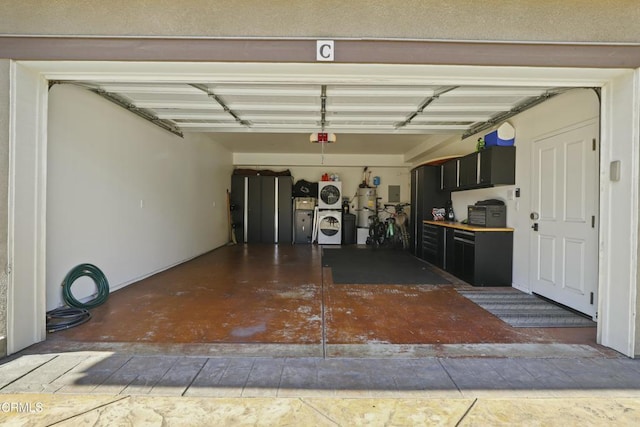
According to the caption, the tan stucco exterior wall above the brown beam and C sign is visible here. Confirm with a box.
[0,0,640,42]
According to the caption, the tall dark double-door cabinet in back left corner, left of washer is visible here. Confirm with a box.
[231,175,293,243]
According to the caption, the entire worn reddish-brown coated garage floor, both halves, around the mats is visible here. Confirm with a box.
[49,245,595,344]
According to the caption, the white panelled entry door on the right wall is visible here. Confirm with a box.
[530,123,599,319]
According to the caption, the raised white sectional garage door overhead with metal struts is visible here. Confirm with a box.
[62,81,563,152]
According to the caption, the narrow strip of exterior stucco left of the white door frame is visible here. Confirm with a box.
[0,60,10,356]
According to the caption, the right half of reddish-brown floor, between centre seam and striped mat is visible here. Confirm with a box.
[326,285,531,344]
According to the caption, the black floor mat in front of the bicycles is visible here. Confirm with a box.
[322,247,450,285]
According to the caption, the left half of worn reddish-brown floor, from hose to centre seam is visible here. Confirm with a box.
[50,246,322,344]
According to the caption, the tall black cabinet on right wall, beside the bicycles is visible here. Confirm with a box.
[409,165,451,258]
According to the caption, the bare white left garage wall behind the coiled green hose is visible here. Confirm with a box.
[47,85,232,309]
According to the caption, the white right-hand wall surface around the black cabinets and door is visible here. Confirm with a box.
[416,89,600,290]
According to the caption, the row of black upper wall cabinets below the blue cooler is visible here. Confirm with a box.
[441,146,516,191]
